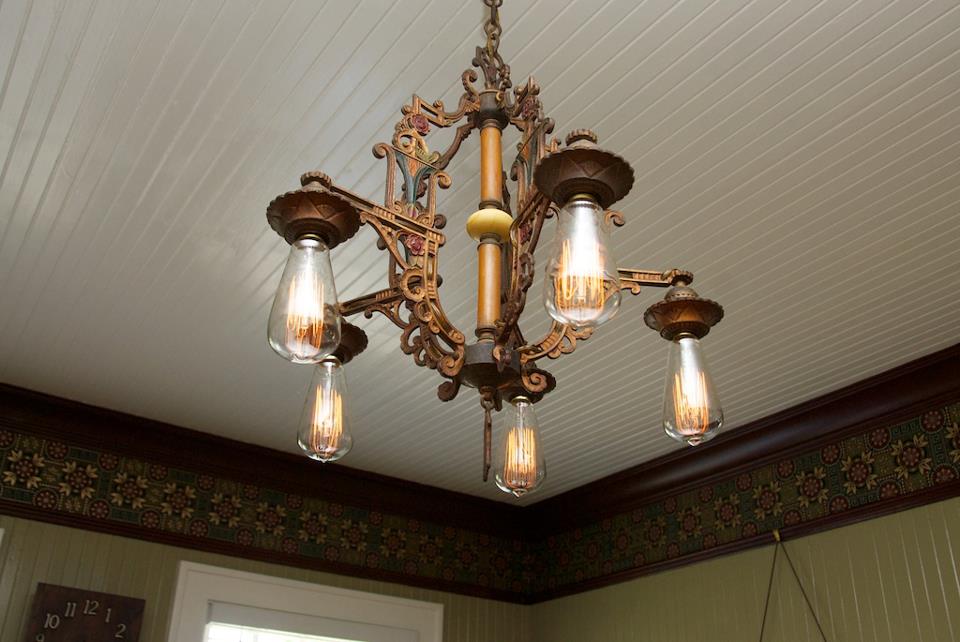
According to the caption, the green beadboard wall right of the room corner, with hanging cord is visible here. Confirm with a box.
[532,499,960,642]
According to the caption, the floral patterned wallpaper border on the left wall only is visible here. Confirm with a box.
[0,429,530,594]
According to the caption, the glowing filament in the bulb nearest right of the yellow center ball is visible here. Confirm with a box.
[554,240,606,322]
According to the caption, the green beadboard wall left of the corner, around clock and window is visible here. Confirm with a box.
[0,515,531,642]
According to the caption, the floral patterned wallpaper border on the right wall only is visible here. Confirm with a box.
[529,404,960,594]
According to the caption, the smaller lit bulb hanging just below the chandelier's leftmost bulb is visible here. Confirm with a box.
[297,357,353,461]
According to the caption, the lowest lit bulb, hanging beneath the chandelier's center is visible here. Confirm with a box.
[494,397,547,497]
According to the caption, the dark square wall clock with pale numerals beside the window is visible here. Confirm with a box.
[23,584,145,642]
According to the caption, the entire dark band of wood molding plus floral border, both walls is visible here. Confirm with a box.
[0,345,960,604]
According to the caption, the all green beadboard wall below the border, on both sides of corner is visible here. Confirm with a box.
[0,499,960,642]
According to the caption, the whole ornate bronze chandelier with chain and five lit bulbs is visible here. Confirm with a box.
[267,0,723,497]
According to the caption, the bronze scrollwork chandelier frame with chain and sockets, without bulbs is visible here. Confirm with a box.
[267,0,722,484]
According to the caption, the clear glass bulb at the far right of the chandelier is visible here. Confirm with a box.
[663,335,723,446]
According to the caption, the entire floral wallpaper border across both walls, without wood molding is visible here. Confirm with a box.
[0,403,960,600]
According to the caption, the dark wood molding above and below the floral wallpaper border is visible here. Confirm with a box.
[0,345,960,603]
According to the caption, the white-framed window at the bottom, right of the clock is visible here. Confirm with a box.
[168,562,443,642]
